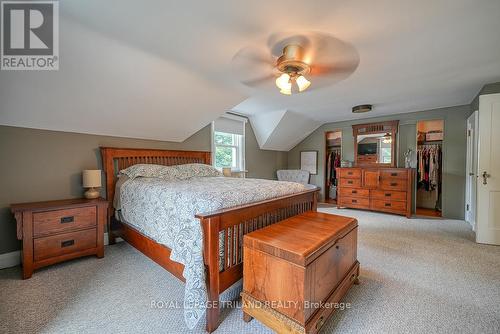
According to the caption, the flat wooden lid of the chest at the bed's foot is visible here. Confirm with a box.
[243,212,358,266]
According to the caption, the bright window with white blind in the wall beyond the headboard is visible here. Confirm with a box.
[212,115,246,171]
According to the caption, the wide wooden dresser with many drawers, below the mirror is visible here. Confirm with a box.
[337,167,414,218]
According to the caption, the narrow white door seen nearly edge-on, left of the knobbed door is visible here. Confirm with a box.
[465,110,478,231]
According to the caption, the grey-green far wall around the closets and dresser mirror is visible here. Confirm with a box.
[288,105,470,219]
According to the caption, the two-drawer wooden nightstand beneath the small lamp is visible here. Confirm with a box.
[11,198,108,279]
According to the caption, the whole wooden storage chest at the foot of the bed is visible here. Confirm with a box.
[242,212,359,333]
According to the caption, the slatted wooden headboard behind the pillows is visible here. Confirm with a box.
[100,147,211,205]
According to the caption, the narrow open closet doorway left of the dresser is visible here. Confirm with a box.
[325,130,342,204]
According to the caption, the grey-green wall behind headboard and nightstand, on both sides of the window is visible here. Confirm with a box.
[0,124,287,254]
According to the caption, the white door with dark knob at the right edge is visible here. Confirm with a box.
[476,94,500,245]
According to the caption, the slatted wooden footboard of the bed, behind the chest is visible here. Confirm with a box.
[196,189,318,332]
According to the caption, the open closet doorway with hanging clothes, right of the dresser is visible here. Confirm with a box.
[416,120,444,217]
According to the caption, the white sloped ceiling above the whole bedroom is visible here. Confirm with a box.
[0,0,500,150]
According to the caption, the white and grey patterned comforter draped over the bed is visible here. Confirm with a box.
[120,177,308,328]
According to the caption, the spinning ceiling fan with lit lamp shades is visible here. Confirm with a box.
[232,32,359,95]
